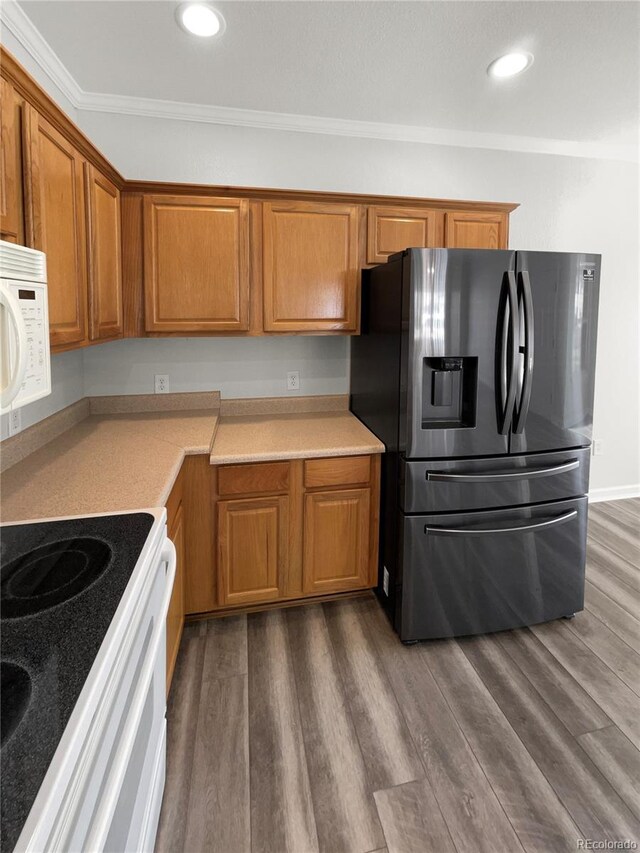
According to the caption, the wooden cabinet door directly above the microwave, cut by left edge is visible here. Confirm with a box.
[0,78,24,243]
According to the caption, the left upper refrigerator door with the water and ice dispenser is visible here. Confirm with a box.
[408,249,518,459]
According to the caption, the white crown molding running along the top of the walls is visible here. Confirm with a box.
[0,0,639,162]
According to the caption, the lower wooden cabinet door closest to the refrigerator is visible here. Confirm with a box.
[302,488,371,593]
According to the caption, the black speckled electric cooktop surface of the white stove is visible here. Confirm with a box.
[0,512,153,853]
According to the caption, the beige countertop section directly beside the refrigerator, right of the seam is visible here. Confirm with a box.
[211,412,384,465]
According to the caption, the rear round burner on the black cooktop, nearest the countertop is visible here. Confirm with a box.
[0,537,112,619]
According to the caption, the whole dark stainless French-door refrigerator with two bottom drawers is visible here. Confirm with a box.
[351,249,600,642]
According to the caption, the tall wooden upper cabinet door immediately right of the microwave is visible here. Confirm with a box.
[24,105,87,346]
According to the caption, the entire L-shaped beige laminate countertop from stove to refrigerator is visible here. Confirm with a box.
[1,410,384,522]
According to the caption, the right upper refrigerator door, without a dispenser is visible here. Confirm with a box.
[511,252,600,453]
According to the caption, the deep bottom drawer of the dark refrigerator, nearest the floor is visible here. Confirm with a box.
[396,497,587,642]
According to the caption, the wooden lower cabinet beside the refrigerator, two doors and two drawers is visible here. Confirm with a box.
[213,456,380,608]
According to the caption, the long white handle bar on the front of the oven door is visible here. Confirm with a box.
[84,538,177,851]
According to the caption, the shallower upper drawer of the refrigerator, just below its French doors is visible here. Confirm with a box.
[400,447,590,513]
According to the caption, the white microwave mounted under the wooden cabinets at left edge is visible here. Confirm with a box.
[0,240,51,414]
